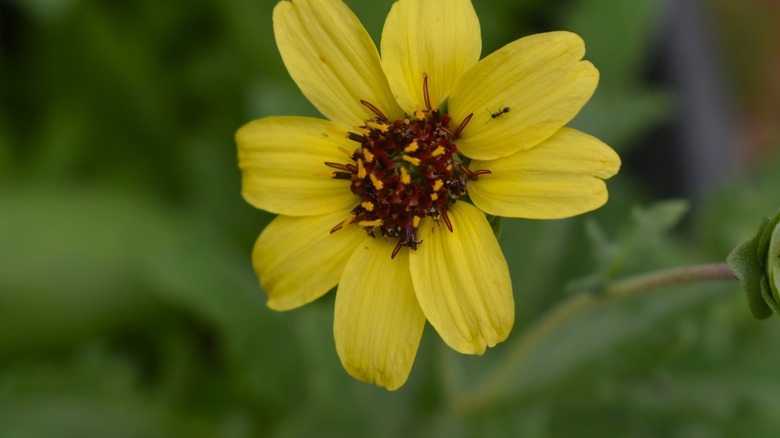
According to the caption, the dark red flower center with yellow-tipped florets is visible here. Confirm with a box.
[325,79,490,257]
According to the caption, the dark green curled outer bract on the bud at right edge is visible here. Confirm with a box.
[726,234,772,319]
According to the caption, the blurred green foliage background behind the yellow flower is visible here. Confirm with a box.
[0,0,780,437]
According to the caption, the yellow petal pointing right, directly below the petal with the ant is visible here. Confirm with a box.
[468,128,620,219]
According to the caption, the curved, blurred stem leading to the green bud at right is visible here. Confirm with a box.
[454,263,737,413]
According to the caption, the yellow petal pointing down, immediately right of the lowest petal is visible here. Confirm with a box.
[410,202,515,354]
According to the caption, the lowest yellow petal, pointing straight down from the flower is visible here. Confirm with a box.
[333,238,425,391]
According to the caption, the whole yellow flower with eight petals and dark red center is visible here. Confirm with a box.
[236,0,620,390]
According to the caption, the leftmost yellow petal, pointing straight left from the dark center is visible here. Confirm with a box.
[236,117,360,216]
